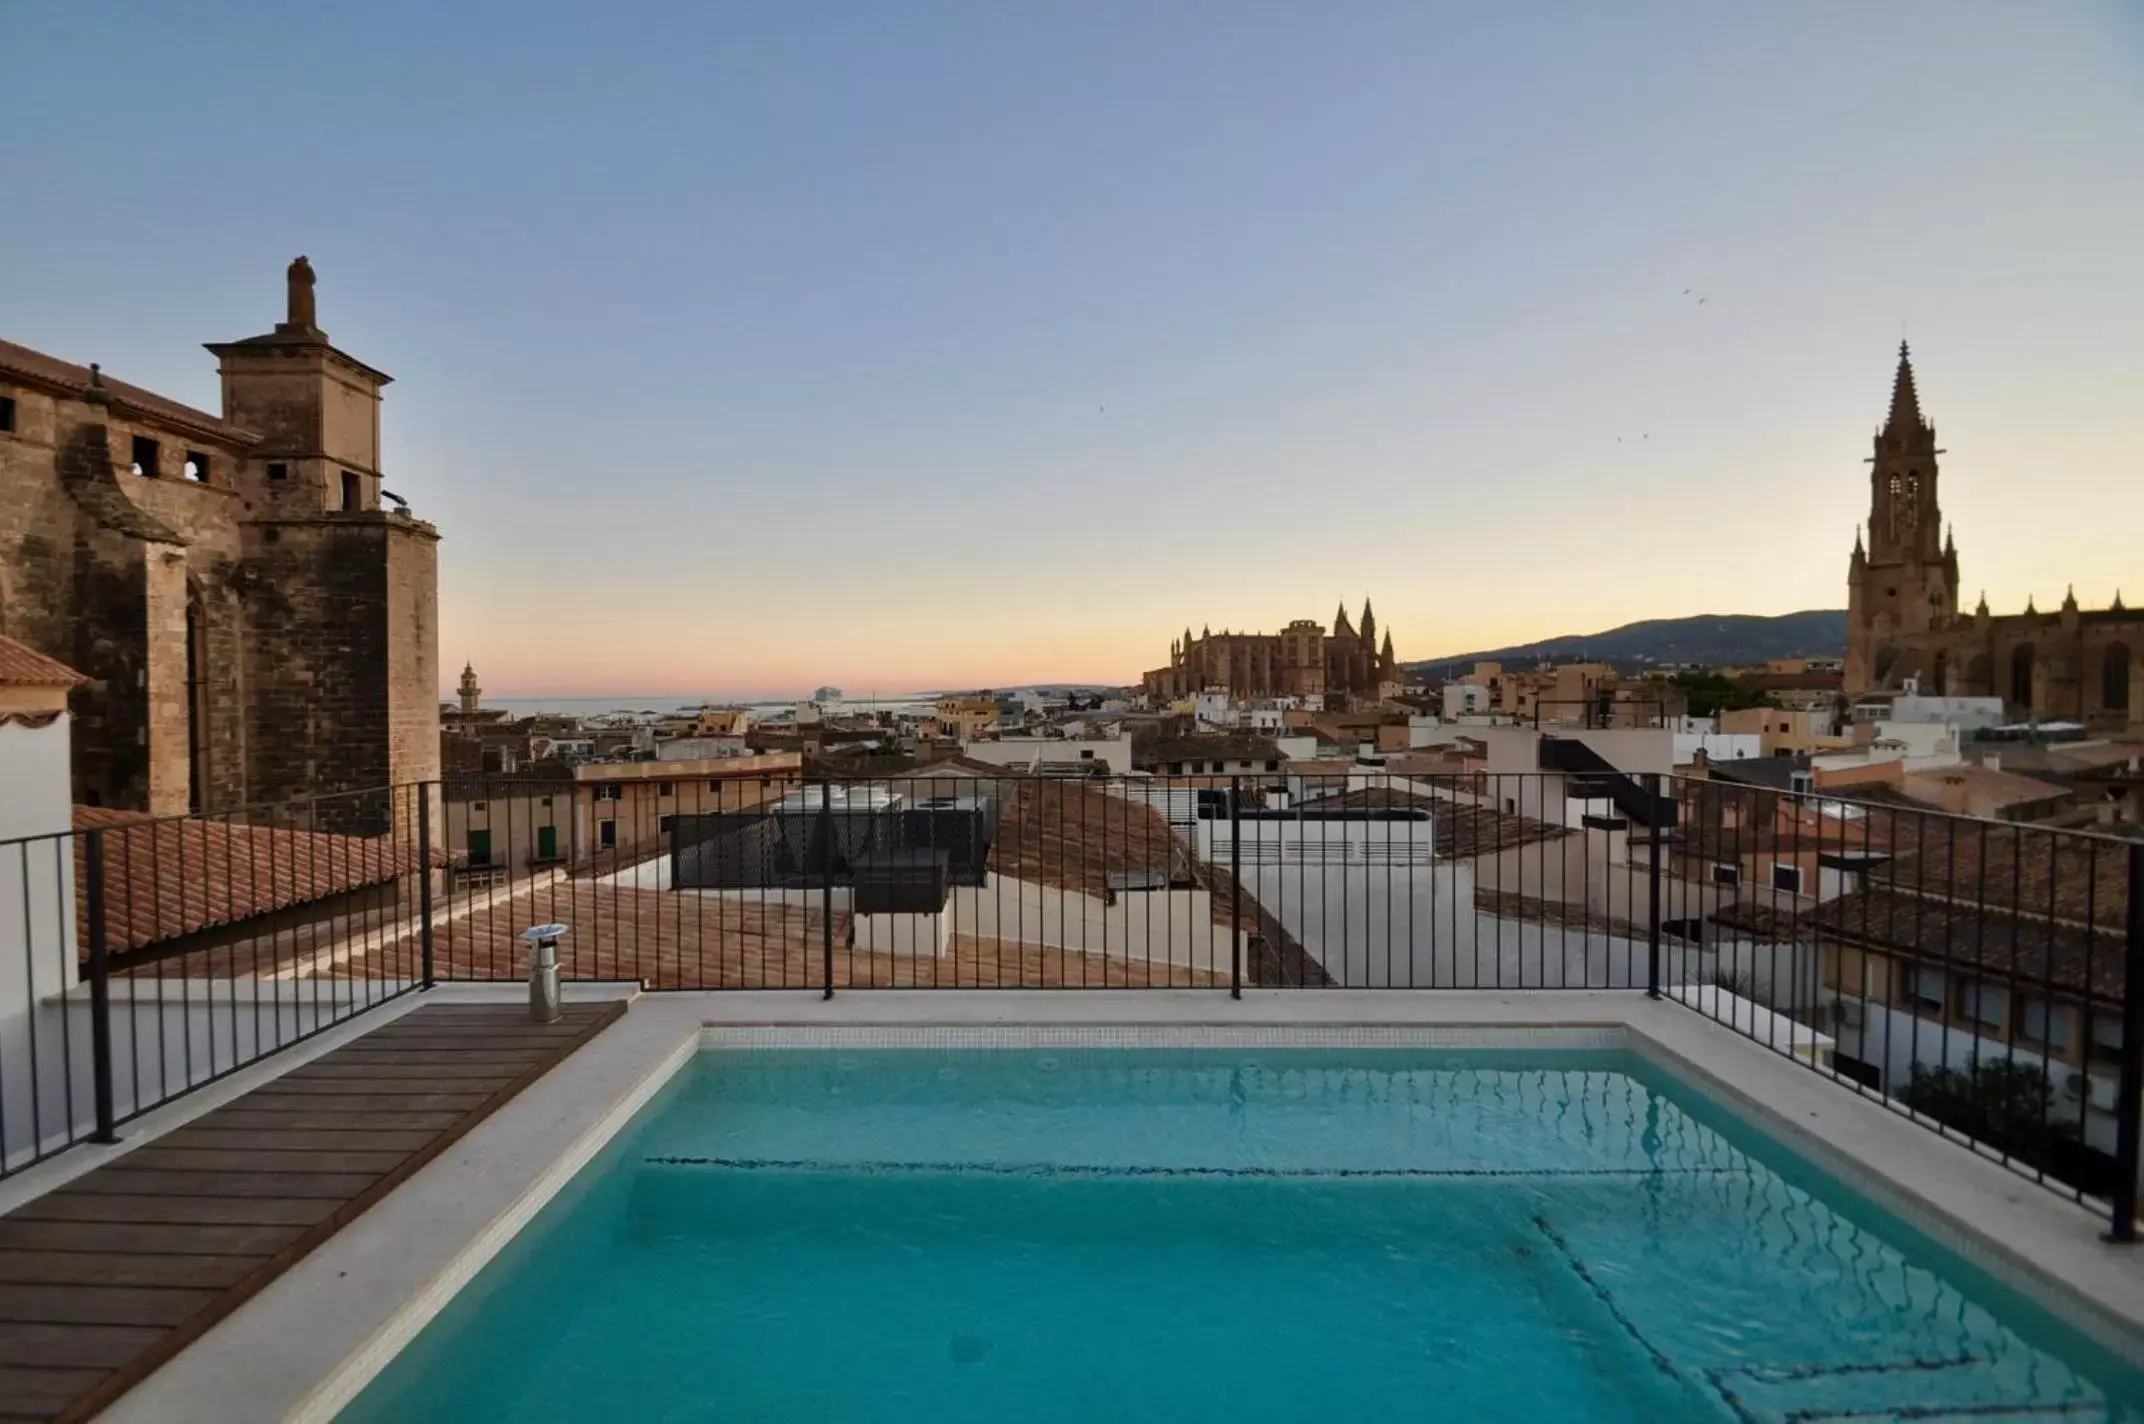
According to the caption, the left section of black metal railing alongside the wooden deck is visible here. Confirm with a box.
[0,787,433,1175]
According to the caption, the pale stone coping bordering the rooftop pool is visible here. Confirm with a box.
[62,987,2144,1424]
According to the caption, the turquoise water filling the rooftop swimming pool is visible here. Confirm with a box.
[343,1049,2144,1424]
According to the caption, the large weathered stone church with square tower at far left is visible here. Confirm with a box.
[0,257,440,832]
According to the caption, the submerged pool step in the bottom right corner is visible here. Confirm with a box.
[1707,1358,2108,1424]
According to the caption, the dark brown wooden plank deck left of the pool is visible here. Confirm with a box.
[0,1002,626,1420]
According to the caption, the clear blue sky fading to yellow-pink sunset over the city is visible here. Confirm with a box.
[0,0,2144,693]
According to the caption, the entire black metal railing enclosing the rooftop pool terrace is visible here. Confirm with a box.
[0,761,2144,1240]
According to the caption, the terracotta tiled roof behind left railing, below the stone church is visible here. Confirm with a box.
[75,806,444,954]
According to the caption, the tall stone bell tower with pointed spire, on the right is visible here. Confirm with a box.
[1846,341,1957,695]
